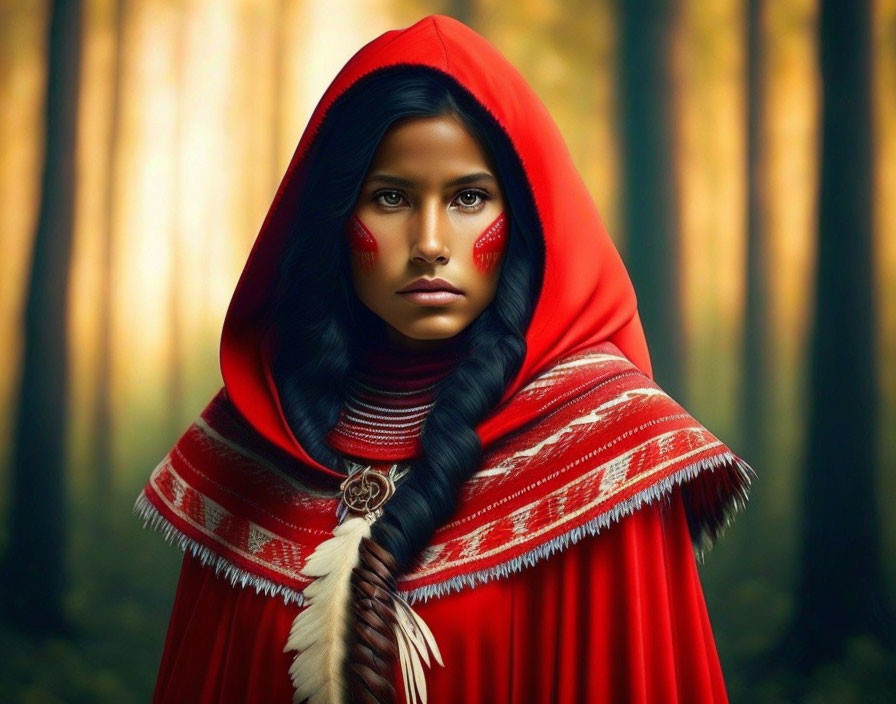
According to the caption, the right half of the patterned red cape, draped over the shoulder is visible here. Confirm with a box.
[400,344,753,599]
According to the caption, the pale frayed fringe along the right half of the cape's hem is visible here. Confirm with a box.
[397,452,756,604]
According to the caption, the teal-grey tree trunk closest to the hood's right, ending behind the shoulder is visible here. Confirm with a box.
[618,0,683,399]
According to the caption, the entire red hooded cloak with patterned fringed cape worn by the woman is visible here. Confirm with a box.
[135,15,753,704]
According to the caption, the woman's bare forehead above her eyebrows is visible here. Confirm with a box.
[369,115,490,176]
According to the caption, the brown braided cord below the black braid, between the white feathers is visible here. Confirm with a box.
[346,538,398,704]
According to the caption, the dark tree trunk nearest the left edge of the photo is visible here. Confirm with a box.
[2,0,81,635]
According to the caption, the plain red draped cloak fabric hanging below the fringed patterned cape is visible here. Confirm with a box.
[153,490,727,704]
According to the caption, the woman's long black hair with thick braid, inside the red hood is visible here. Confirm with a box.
[269,66,544,572]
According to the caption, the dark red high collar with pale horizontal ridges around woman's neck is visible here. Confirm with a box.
[325,335,466,462]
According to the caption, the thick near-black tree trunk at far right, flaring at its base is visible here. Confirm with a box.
[779,0,896,671]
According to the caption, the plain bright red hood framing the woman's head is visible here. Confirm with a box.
[221,15,652,474]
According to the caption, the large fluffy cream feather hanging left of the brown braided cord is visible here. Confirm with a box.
[283,516,370,704]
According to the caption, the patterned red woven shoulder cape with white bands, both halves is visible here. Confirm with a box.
[135,343,753,603]
